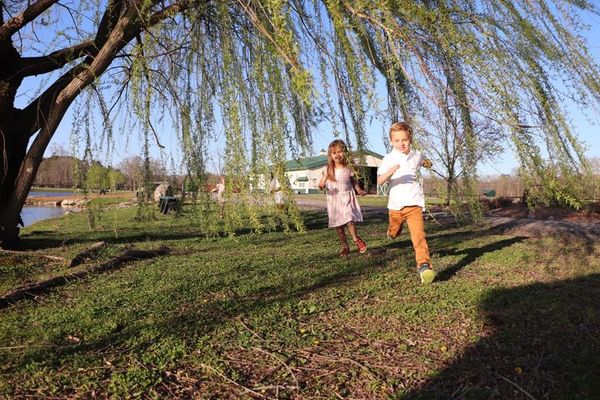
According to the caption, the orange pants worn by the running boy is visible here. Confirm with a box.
[388,206,429,268]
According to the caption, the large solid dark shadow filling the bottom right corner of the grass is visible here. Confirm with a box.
[404,274,600,400]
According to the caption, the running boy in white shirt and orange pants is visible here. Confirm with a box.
[377,122,435,284]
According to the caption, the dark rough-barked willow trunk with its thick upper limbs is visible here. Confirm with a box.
[0,0,189,248]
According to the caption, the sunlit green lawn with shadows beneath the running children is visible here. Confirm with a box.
[0,208,600,399]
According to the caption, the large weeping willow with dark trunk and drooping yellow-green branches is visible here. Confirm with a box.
[0,0,600,246]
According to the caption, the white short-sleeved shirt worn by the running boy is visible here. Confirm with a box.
[377,149,425,210]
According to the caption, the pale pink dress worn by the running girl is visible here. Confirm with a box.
[326,167,363,228]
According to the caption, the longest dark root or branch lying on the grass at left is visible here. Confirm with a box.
[0,246,171,308]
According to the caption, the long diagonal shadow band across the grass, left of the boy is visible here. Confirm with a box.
[7,245,380,371]
